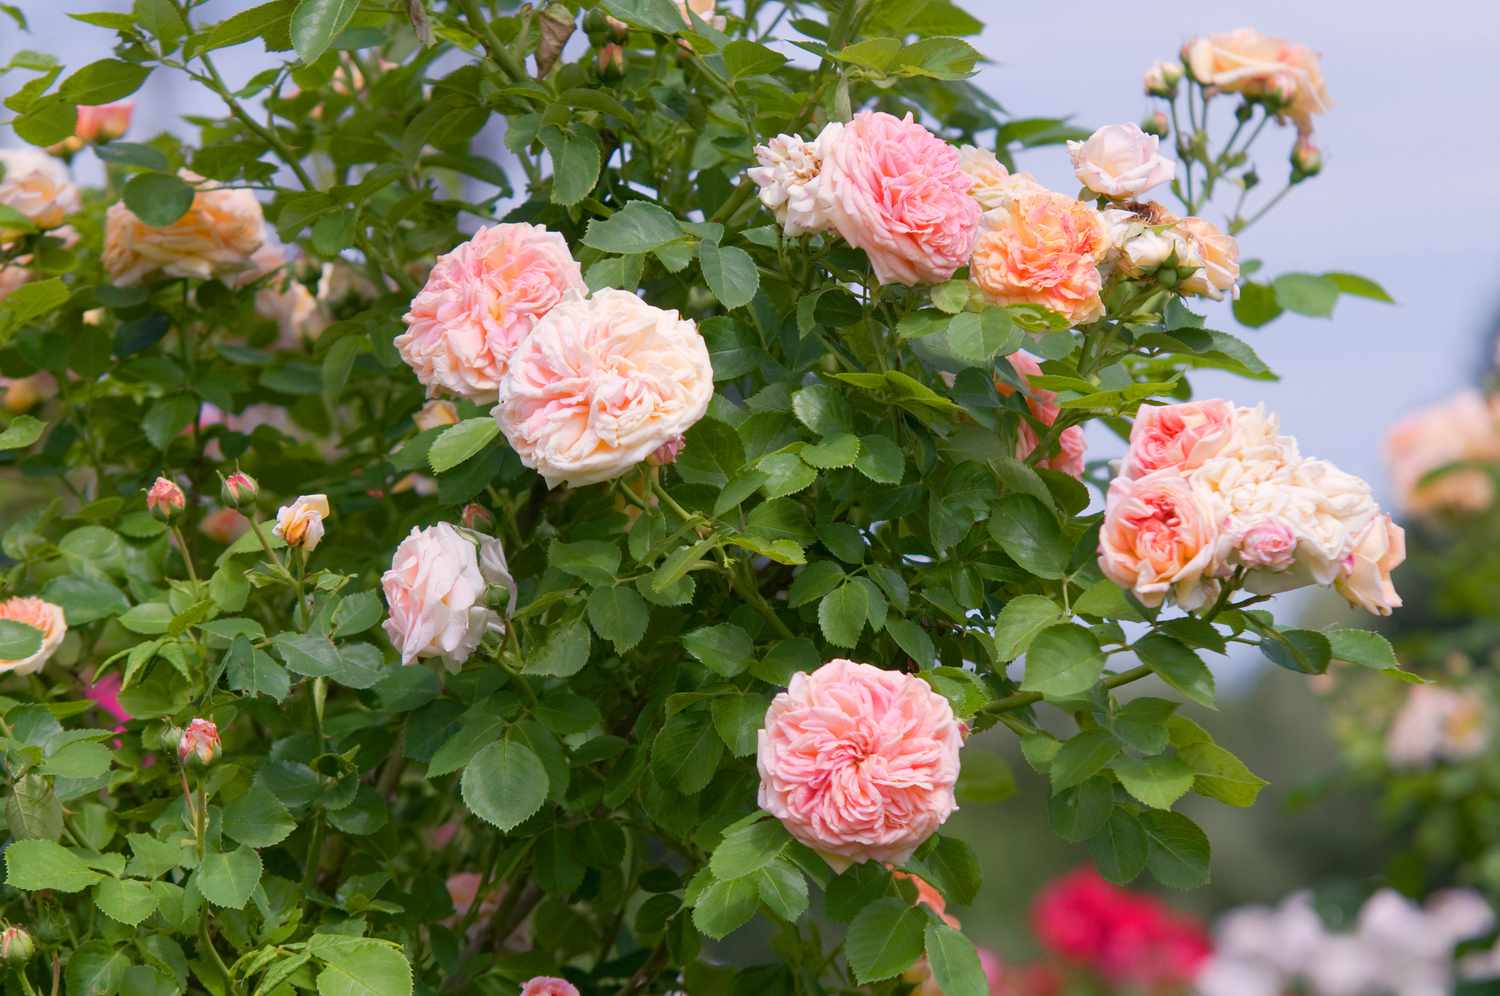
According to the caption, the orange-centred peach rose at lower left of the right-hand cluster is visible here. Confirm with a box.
[1100,467,1220,609]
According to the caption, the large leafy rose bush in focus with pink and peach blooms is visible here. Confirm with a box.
[0,0,1401,996]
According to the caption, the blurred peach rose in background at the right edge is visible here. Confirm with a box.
[1386,390,1500,515]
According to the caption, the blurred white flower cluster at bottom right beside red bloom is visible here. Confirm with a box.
[1197,890,1500,996]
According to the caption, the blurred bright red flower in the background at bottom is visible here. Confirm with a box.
[1032,869,1212,986]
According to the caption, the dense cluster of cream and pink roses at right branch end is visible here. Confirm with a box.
[1100,401,1406,615]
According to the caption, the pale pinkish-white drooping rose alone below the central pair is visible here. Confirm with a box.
[381,522,516,671]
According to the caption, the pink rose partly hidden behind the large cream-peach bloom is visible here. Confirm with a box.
[396,225,588,404]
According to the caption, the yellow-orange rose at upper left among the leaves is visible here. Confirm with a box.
[104,170,266,287]
